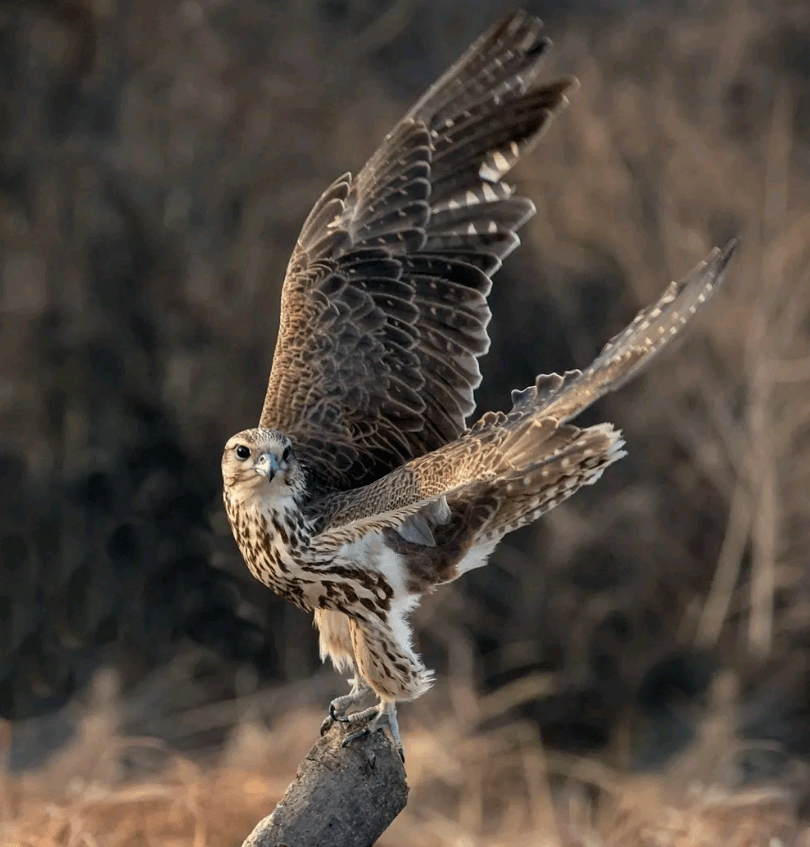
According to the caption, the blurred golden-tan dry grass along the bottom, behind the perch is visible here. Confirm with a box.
[0,680,810,847]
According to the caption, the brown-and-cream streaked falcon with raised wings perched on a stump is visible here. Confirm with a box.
[222,12,734,754]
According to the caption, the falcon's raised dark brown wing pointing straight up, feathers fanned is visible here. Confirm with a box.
[260,13,575,490]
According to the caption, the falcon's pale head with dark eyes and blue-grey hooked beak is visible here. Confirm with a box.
[222,429,304,500]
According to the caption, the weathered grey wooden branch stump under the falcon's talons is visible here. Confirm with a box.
[242,726,408,847]
